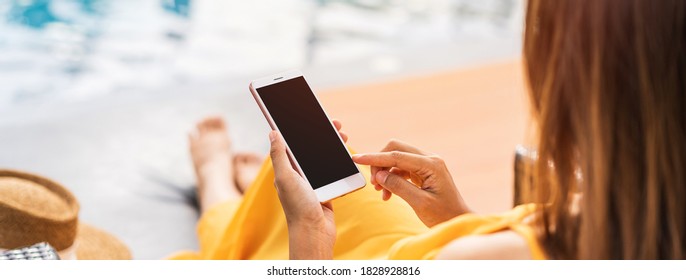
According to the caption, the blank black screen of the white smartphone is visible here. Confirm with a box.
[257,76,358,189]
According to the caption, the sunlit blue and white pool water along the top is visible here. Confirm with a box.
[0,0,523,108]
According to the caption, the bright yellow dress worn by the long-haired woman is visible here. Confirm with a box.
[170,159,544,260]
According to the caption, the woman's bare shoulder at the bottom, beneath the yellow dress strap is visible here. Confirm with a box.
[436,230,533,260]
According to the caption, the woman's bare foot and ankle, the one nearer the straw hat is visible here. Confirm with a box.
[188,117,242,212]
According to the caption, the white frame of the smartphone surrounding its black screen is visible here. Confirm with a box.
[250,70,366,203]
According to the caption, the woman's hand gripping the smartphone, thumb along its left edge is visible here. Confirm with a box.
[269,120,348,259]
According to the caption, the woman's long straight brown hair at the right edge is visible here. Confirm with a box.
[524,0,686,259]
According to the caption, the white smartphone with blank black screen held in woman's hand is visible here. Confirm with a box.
[250,70,366,202]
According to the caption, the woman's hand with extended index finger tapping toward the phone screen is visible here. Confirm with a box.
[353,140,470,227]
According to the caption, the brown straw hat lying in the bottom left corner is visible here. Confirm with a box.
[0,169,131,260]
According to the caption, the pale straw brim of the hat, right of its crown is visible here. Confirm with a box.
[74,223,131,260]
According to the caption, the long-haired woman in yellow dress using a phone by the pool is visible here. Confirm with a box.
[168,0,686,259]
